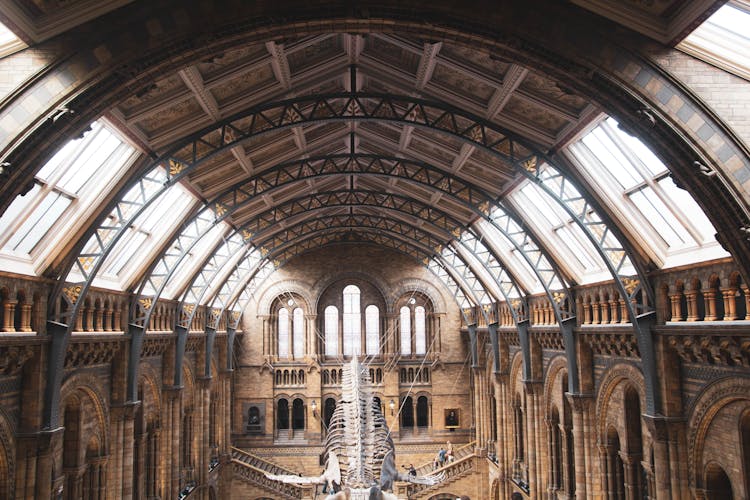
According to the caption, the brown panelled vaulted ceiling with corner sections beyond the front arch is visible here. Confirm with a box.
[2,0,736,326]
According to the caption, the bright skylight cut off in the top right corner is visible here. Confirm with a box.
[677,0,750,80]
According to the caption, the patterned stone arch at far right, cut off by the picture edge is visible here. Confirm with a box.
[687,377,750,493]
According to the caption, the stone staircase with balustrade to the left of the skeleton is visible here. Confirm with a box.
[232,447,313,499]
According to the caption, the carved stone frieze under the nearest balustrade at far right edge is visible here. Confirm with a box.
[669,335,750,367]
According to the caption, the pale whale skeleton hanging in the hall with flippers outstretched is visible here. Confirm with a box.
[266,356,444,499]
